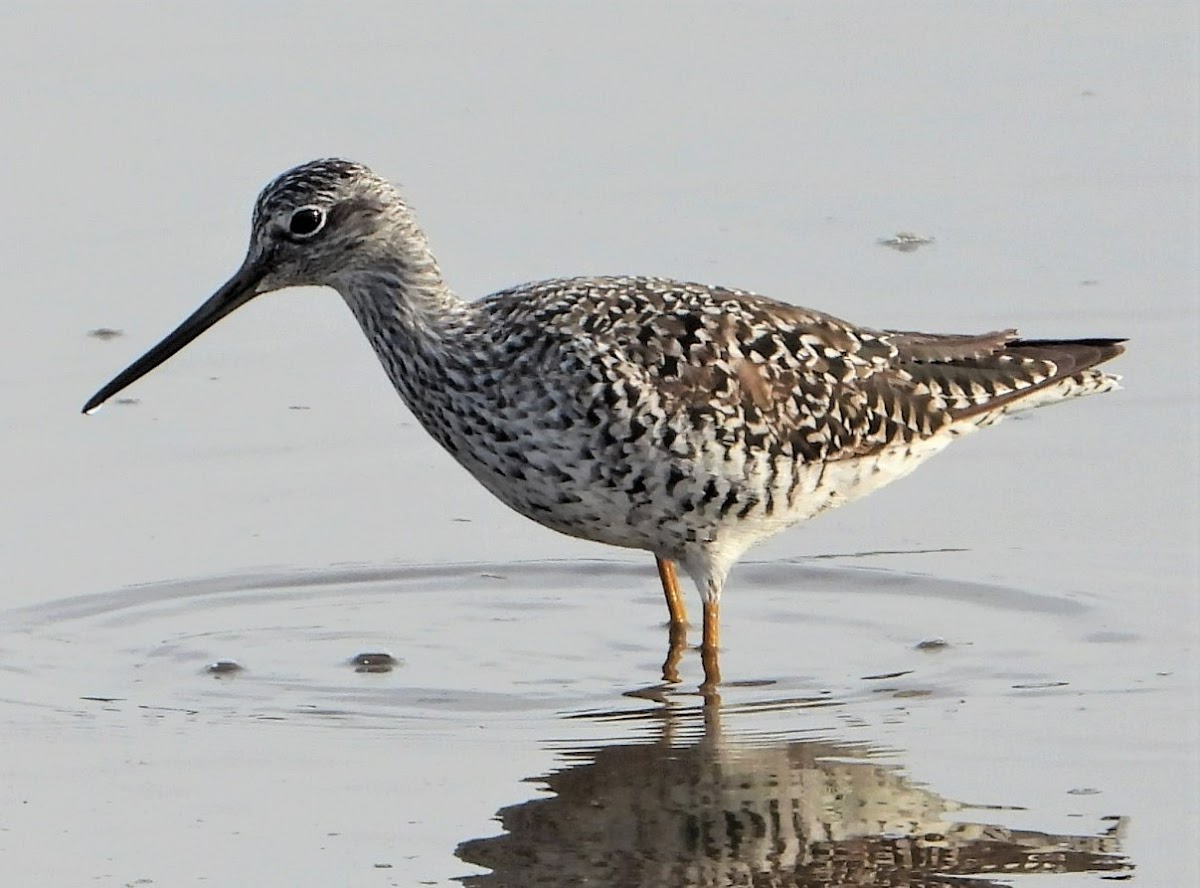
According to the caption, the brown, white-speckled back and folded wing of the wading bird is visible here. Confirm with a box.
[465,277,1041,460]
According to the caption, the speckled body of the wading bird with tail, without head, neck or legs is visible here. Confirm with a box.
[388,277,1121,577]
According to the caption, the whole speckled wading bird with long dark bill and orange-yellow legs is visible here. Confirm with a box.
[84,160,1122,686]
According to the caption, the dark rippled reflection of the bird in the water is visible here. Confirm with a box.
[456,706,1133,888]
